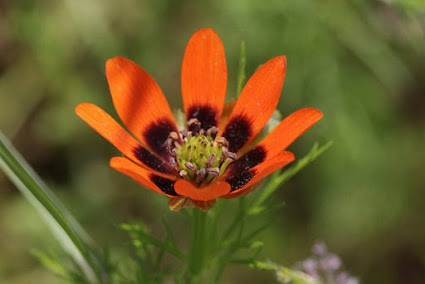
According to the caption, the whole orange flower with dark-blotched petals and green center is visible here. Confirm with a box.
[75,29,322,211]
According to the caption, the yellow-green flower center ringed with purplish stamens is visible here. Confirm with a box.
[169,128,236,186]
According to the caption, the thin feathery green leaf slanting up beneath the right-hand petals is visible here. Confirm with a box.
[250,141,333,207]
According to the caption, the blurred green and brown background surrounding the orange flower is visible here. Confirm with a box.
[0,0,425,284]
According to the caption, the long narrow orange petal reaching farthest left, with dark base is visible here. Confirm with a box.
[75,103,174,174]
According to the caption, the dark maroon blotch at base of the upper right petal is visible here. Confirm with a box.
[223,115,252,153]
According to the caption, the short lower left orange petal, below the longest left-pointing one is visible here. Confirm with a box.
[110,157,178,197]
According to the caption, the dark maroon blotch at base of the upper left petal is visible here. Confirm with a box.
[142,118,177,157]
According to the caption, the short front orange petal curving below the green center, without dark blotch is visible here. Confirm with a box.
[174,180,230,201]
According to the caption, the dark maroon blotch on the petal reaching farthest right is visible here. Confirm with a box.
[226,146,267,176]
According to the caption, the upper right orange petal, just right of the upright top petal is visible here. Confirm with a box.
[221,56,286,152]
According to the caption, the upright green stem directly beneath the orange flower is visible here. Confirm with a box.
[189,209,207,283]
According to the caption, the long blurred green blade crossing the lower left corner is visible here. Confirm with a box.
[0,131,101,283]
